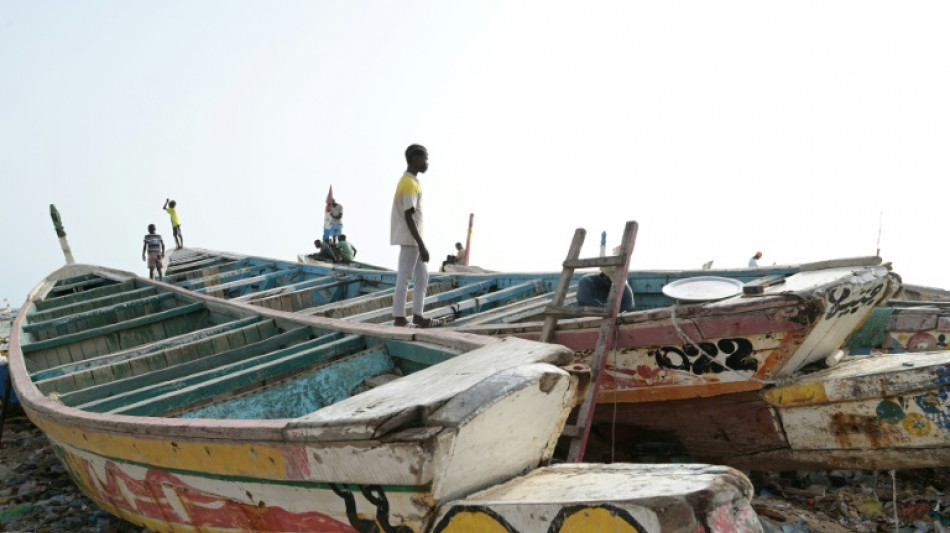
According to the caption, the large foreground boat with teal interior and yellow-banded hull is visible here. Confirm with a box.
[10,265,577,532]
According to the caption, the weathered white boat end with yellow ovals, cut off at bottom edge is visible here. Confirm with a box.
[434,464,761,533]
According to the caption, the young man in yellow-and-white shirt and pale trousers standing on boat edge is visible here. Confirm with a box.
[389,144,434,328]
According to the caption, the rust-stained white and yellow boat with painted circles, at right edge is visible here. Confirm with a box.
[760,350,950,470]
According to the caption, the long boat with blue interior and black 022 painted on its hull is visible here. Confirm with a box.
[152,246,950,470]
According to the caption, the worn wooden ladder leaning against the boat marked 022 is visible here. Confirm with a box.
[541,221,637,462]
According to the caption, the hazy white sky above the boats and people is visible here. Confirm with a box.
[0,0,950,307]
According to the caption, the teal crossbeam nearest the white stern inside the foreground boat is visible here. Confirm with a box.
[106,336,366,416]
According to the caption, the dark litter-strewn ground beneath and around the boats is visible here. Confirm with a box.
[0,406,950,533]
